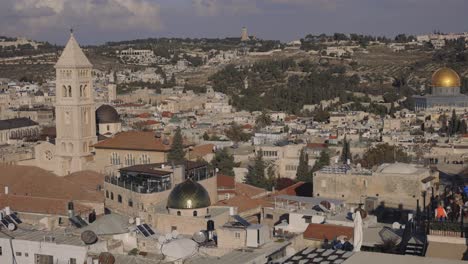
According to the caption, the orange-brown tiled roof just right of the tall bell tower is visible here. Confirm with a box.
[94,131,188,152]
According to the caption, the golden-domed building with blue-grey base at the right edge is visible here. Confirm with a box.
[413,68,468,111]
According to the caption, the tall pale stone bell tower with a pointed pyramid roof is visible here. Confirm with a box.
[55,31,97,175]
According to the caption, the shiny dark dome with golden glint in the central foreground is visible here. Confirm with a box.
[167,179,211,209]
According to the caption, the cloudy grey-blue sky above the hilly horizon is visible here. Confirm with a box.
[0,0,468,44]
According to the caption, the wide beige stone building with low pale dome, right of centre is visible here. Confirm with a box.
[313,163,438,208]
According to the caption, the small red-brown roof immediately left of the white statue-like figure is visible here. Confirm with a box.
[304,224,354,240]
